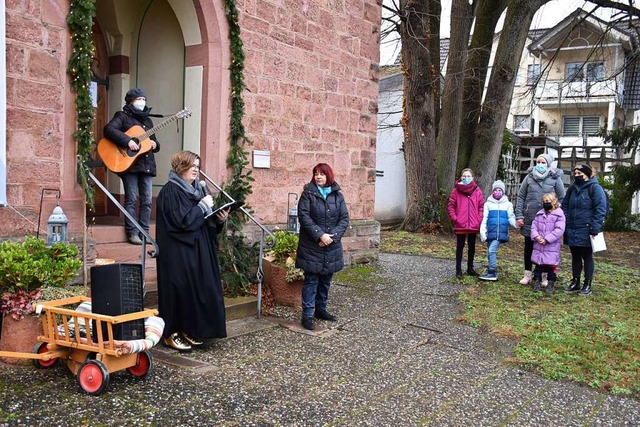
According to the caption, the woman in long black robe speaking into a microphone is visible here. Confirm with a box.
[156,151,228,351]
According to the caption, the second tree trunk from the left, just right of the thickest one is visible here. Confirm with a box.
[436,0,473,194]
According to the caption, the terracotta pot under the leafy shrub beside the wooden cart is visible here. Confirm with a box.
[0,315,43,365]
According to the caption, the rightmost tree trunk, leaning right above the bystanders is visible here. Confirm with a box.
[469,0,549,194]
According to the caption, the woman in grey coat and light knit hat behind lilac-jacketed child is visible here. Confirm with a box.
[515,154,565,285]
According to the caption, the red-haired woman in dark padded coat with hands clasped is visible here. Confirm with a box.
[296,163,349,330]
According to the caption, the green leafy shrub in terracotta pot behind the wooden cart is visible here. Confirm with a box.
[0,237,82,364]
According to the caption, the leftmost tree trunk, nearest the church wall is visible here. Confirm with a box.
[400,0,439,231]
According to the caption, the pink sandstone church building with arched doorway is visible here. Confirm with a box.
[0,0,381,268]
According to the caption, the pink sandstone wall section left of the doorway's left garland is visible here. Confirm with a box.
[0,0,83,236]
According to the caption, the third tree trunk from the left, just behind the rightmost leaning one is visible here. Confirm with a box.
[458,0,507,179]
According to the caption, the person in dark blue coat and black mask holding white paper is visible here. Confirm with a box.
[562,165,607,296]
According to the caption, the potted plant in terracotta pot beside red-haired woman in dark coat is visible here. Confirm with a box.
[264,230,304,306]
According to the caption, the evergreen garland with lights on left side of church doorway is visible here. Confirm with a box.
[67,0,96,205]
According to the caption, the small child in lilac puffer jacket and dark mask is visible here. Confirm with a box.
[531,193,566,293]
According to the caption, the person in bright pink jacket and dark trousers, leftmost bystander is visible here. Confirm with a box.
[448,168,484,279]
